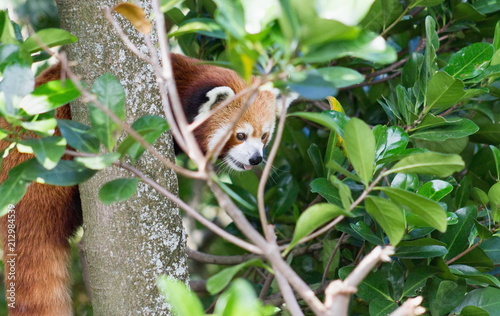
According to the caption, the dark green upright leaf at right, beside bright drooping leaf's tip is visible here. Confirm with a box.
[440,206,477,260]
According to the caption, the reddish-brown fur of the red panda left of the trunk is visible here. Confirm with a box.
[0,66,81,316]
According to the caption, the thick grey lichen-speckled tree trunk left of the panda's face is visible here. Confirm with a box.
[57,0,188,315]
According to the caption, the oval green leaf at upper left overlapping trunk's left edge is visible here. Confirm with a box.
[22,29,77,54]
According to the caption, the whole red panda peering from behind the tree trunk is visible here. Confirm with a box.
[0,54,294,316]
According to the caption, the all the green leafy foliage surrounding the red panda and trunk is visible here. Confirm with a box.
[0,0,500,315]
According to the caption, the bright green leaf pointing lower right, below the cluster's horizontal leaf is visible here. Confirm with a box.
[379,187,446,232]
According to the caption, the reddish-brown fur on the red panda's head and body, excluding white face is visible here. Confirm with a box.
[0,54,275,316]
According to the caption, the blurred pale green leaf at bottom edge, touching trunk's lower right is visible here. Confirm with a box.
[156,275,205,316]
